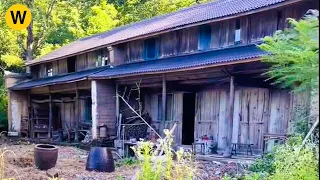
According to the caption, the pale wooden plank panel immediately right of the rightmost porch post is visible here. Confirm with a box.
[232,88,270,149]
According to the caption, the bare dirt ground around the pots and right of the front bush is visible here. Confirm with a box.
[0,141,247,180]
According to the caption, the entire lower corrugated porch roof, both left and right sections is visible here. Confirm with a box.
[10,45,268,90]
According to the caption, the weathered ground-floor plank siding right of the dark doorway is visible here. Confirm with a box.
[195,87,309,150]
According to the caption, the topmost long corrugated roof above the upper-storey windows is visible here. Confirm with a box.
[26,0,290,65]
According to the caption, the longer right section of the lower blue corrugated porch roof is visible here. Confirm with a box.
[89,45,268,79]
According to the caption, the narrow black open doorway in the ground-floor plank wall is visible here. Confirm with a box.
[182,93,196,145]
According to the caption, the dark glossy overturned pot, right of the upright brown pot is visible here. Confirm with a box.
[86,147,115,172]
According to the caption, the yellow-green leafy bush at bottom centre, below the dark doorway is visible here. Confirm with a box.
[133,130,196,180]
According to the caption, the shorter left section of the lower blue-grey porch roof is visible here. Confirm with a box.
[9,67,108,90]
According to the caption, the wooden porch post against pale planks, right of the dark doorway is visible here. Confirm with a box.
[225,76,235,155]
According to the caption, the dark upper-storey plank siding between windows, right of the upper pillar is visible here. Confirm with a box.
[125,1,317,62]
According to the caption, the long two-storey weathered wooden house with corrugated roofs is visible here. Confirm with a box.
[6,0,318,153]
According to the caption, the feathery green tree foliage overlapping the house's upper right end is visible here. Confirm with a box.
[260,16,319,91]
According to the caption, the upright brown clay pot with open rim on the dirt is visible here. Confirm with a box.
[34,144,58,170]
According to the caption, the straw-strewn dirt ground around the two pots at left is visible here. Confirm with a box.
[0,144,137,180]
